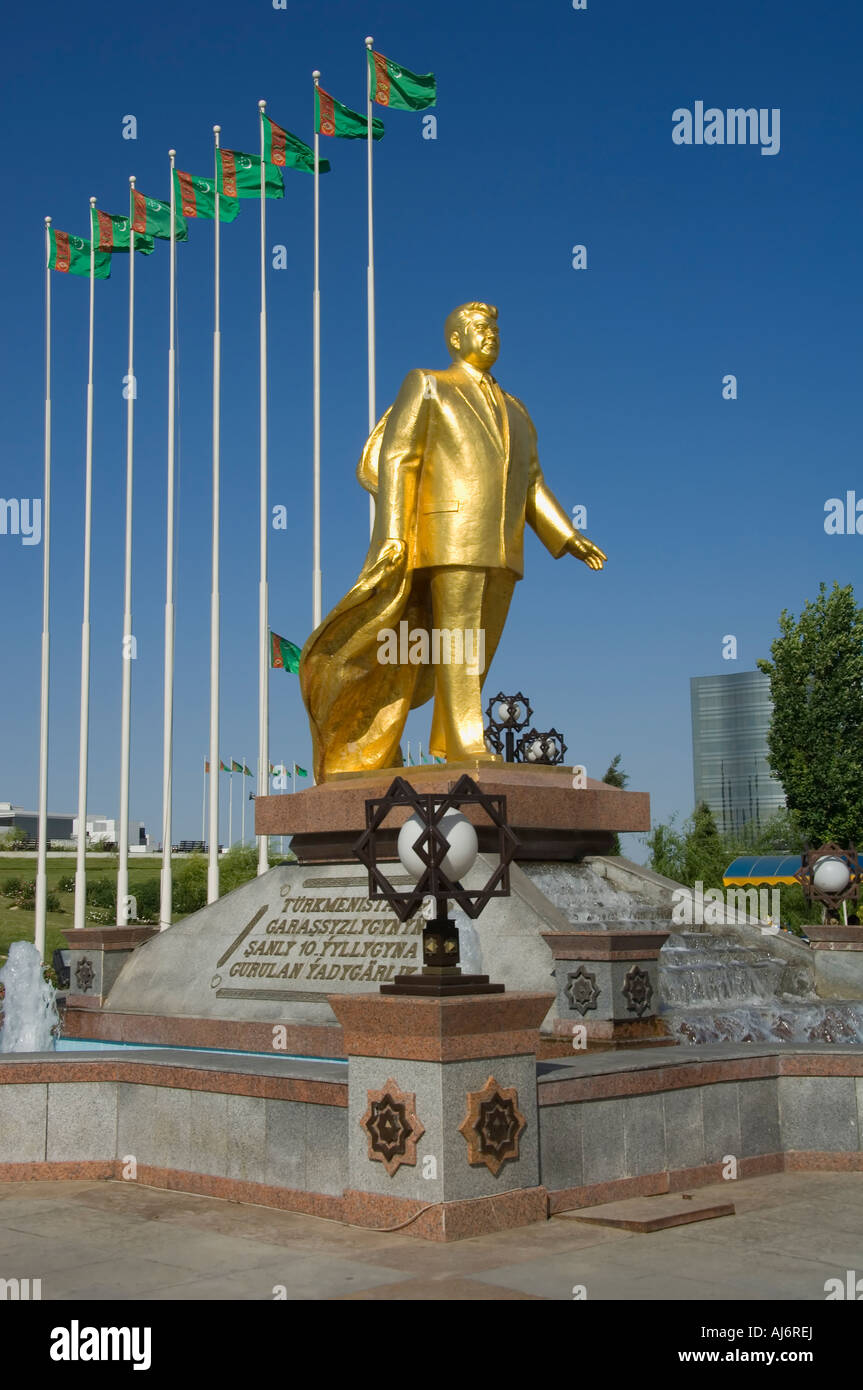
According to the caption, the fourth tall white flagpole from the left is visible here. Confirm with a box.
[158,150,176,931]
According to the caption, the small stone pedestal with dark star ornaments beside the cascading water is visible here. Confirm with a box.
[542,922,675,1047]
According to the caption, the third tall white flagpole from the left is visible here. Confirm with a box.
[117,174,136,927]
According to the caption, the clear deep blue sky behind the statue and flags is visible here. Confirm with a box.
[0,0,863,848]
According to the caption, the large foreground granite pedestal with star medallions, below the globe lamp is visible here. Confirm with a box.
[329,992,552,1240]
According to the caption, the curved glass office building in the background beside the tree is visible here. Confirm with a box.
[689,671,785,833]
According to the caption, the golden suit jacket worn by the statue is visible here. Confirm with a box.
[357,364,575,577]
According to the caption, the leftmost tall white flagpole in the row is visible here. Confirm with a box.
[35,217,51,956]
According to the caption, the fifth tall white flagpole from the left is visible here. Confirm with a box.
[207,125,222,902]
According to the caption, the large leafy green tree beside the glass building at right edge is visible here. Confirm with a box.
[757,584,863,845]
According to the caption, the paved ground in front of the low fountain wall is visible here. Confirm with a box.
[0,1173,863,1301]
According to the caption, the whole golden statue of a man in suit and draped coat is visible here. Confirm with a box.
[300,303,607,783]
